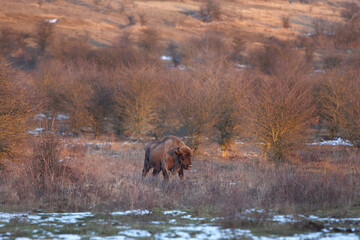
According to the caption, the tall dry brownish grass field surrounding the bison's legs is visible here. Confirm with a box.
[0,137,360,215]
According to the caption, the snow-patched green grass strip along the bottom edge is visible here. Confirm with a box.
[0,209,360,240]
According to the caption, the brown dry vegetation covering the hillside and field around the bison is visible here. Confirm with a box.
[0,0,360,216]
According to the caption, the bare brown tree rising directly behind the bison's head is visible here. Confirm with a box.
[169,63,221,150]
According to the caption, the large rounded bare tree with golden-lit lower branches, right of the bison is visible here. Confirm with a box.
[244,48,315,160]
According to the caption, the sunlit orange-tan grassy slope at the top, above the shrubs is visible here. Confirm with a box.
[0,0,350,48]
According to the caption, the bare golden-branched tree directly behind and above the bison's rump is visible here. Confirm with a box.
[114,65,161,137]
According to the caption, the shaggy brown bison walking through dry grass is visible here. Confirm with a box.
[142,136,192,180]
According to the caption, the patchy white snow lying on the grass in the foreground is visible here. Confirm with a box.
[0,209,360,240]
